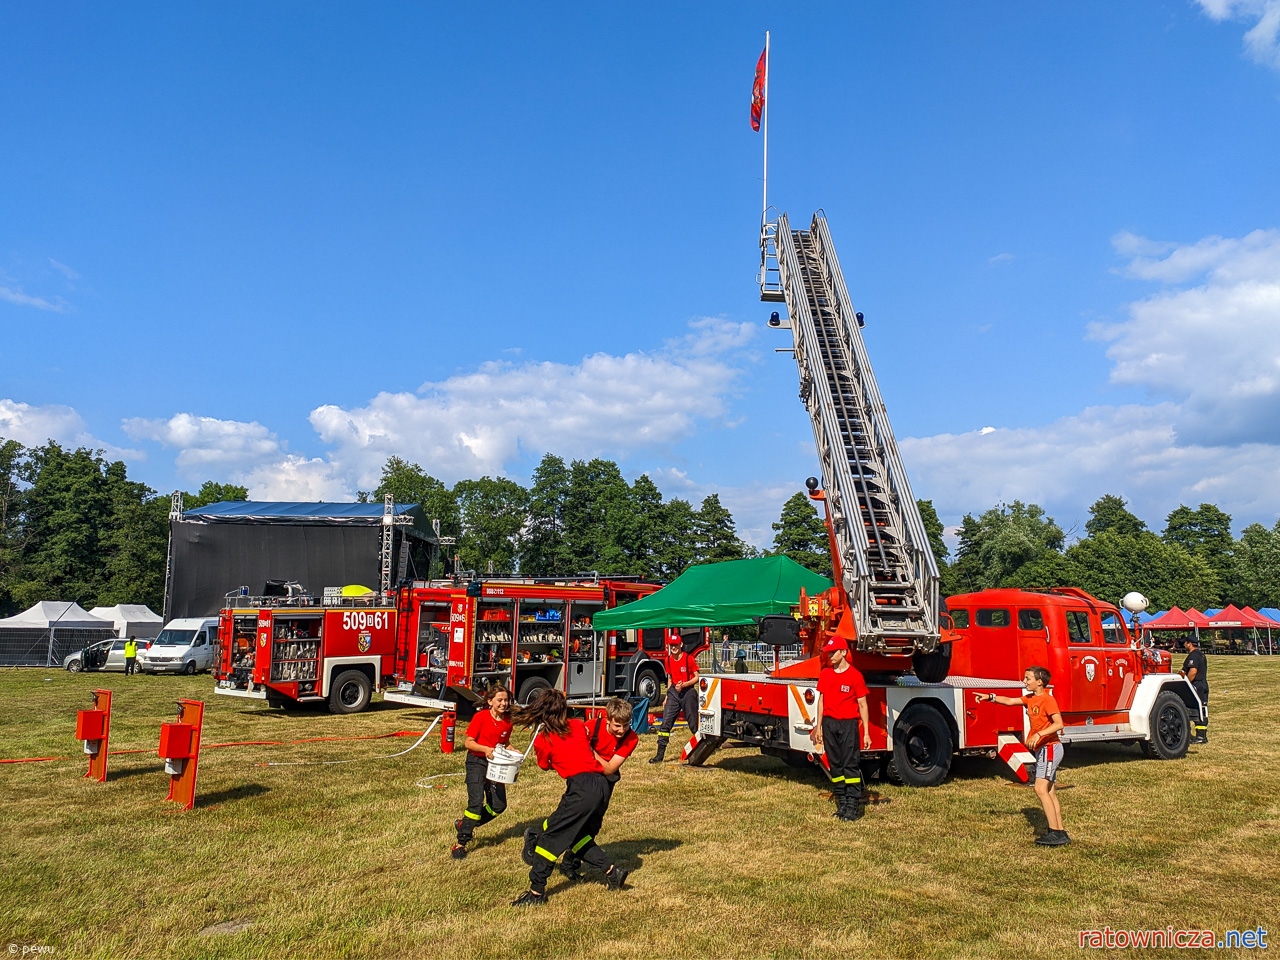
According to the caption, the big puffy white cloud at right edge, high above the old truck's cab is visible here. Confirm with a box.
[1091,230,1280,445]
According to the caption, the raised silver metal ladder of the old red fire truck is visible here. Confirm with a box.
[776,214,940,653]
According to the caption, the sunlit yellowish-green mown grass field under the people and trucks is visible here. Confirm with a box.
[0,657,1280,957]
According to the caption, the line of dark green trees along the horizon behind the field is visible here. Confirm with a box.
[0,438,1280,616]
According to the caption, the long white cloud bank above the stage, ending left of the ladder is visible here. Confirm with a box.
[311,319,754,489]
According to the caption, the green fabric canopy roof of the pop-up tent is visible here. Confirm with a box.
[591,557,831,630]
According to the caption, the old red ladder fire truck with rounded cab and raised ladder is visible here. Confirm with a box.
[685,214,1203,786]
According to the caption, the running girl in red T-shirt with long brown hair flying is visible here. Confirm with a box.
[512,690,626,906]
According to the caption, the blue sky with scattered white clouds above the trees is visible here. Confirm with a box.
[0,0,1280,545]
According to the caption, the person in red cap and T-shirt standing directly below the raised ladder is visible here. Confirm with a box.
[809,636,872,820]
